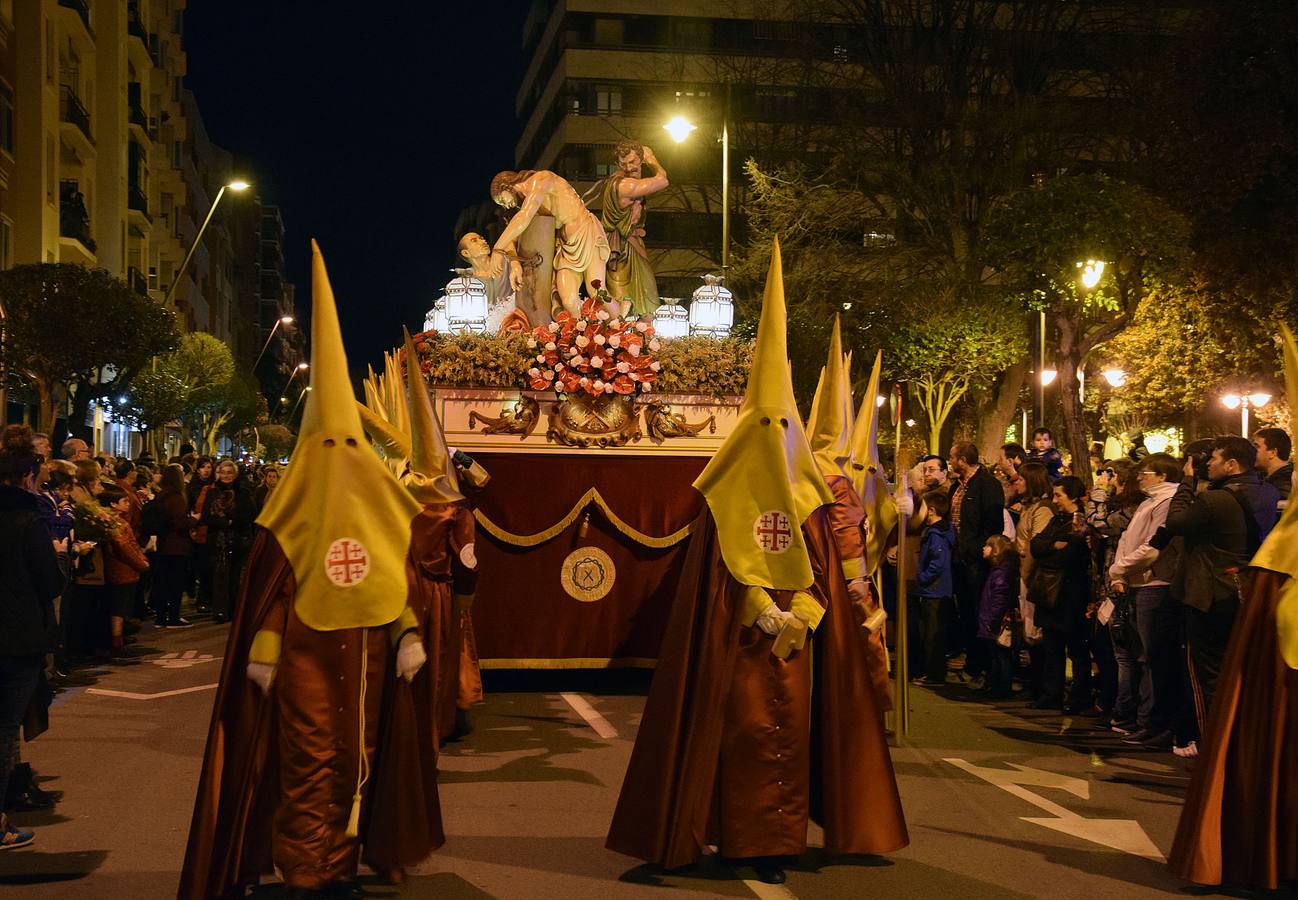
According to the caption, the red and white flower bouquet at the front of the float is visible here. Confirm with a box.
[527,283,662,396]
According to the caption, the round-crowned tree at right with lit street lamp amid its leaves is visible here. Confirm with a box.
[984,175,1189,478]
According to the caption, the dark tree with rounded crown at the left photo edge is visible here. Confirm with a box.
[0,262,178,431]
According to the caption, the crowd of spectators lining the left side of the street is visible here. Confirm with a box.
[0,425,279,849]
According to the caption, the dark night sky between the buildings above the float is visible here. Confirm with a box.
[184,0,528,373]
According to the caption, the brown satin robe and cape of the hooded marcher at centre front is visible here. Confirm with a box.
[606,508,909,869]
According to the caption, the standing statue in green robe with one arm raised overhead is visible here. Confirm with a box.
[600,140,667,317]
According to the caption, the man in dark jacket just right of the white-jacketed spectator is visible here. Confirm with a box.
[1150,435,1280,723]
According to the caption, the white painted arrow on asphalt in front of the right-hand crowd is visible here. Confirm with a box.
[946,758,1167,862]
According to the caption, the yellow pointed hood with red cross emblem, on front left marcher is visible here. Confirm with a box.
[257,240,419,631]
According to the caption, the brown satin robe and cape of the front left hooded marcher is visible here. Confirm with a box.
[178,529,444,900]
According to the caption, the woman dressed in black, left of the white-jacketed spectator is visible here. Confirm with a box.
[1028,475,1094,713]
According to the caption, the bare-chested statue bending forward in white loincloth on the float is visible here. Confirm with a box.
[491,170,609,316]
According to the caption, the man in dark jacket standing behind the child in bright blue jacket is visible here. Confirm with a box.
[948,440,1005,652]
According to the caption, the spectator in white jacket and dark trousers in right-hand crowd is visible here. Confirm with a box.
[1108,453,1184,749]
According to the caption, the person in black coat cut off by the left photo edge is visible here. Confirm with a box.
[0,425,65,849]
